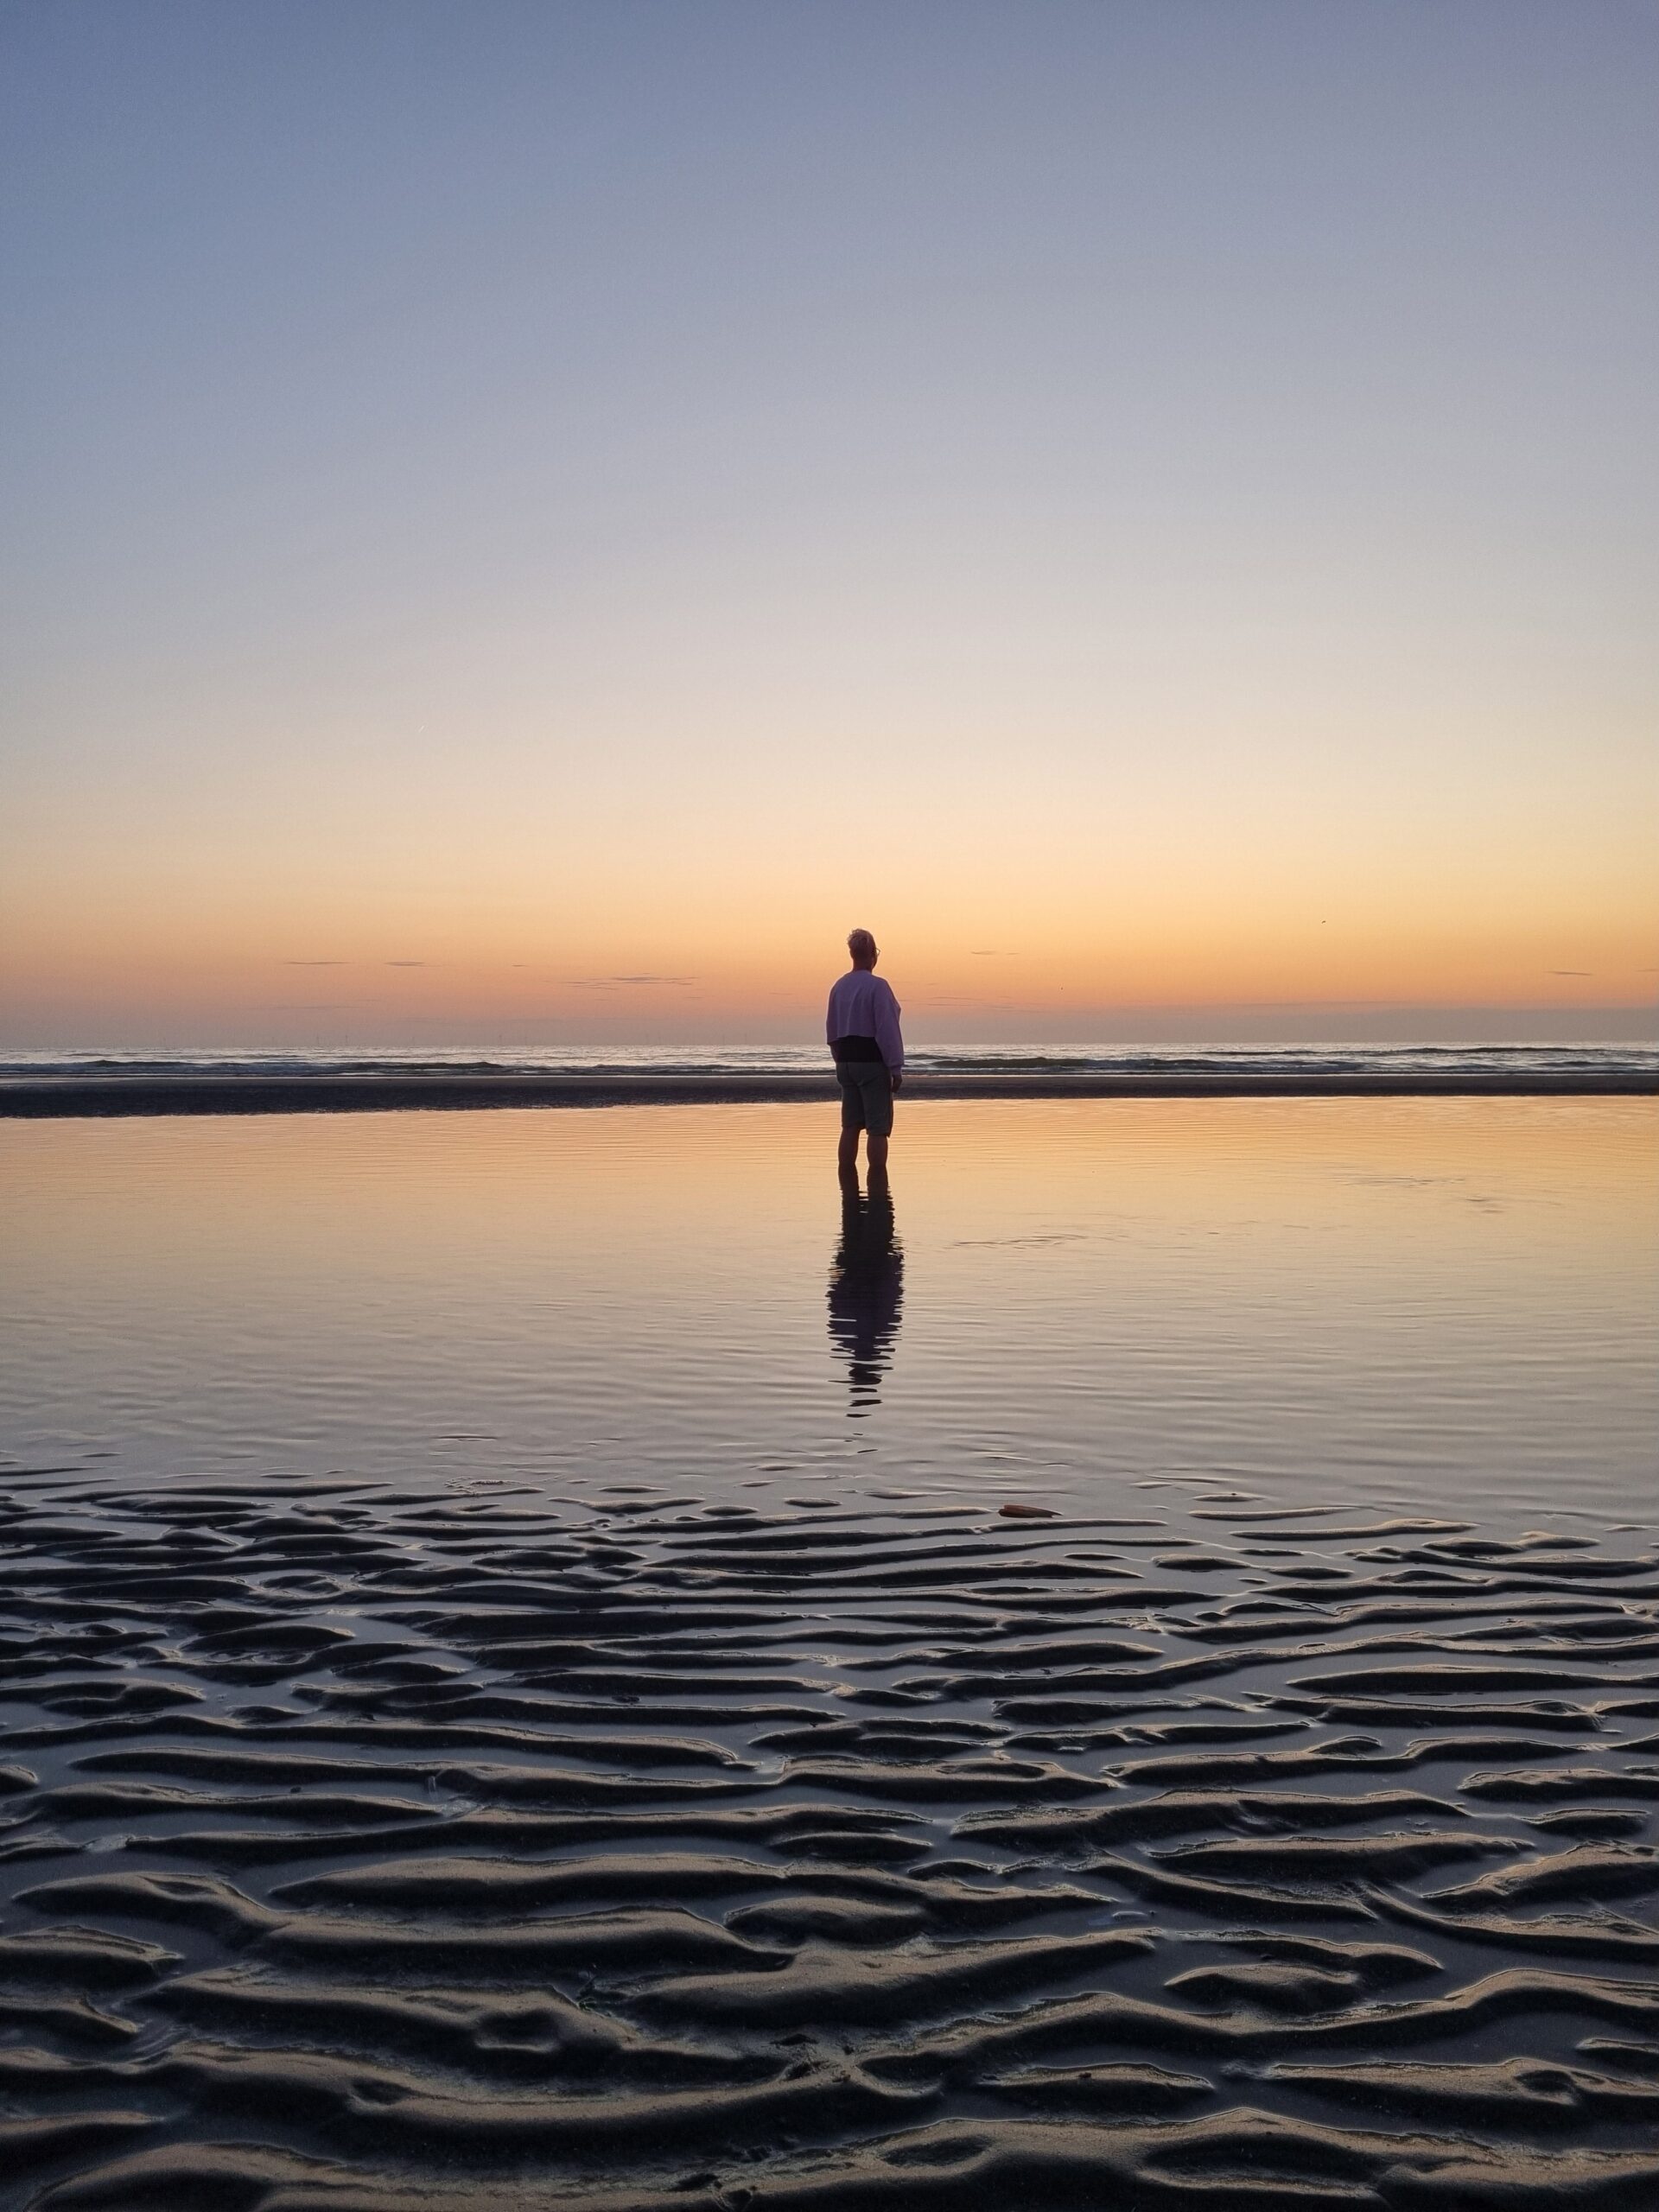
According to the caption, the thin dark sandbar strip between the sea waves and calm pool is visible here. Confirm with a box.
[0,1068,1659,1122]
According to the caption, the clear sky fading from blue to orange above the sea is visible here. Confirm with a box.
[0,0,1659,1046]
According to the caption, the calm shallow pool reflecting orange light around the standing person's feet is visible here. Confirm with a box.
[0,1099,1659,1517]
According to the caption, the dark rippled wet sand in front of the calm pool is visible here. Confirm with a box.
[0,1469,1659,2212]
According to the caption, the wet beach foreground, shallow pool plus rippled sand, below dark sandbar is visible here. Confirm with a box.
[0,1097,1659,2212]
